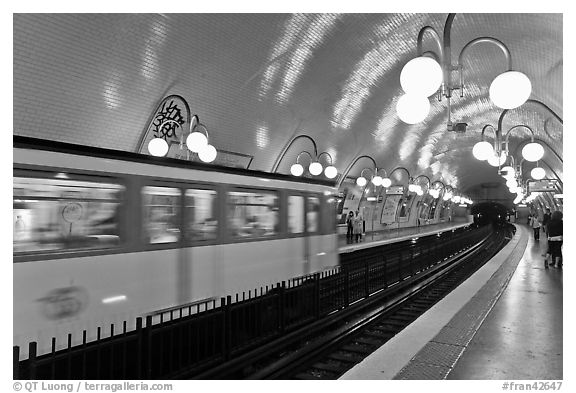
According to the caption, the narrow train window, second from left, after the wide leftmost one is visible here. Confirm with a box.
[142,186,180,244]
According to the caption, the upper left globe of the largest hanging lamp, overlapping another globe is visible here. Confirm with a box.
[400,56,443,97]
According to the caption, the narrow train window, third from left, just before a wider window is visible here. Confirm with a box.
[186,189,218,241]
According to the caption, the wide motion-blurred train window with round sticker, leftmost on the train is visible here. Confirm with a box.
[13,174,124,253]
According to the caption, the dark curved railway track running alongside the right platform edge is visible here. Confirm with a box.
[245,225,510,380]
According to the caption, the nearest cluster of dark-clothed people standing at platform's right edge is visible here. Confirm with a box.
[528,209,563,269]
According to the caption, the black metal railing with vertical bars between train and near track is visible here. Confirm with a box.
[13,222,492,379]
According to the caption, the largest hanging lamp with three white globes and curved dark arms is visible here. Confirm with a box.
[396,13,532,131]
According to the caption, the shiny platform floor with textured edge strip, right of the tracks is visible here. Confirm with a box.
[341,225,563,380]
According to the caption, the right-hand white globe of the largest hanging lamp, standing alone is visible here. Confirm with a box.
[489,71,532,109]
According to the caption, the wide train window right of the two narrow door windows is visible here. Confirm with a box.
[228,191,279,238]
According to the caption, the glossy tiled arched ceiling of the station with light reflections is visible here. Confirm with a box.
[14,14,563,196]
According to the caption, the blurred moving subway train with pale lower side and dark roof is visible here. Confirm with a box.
[13,136,338,359]
